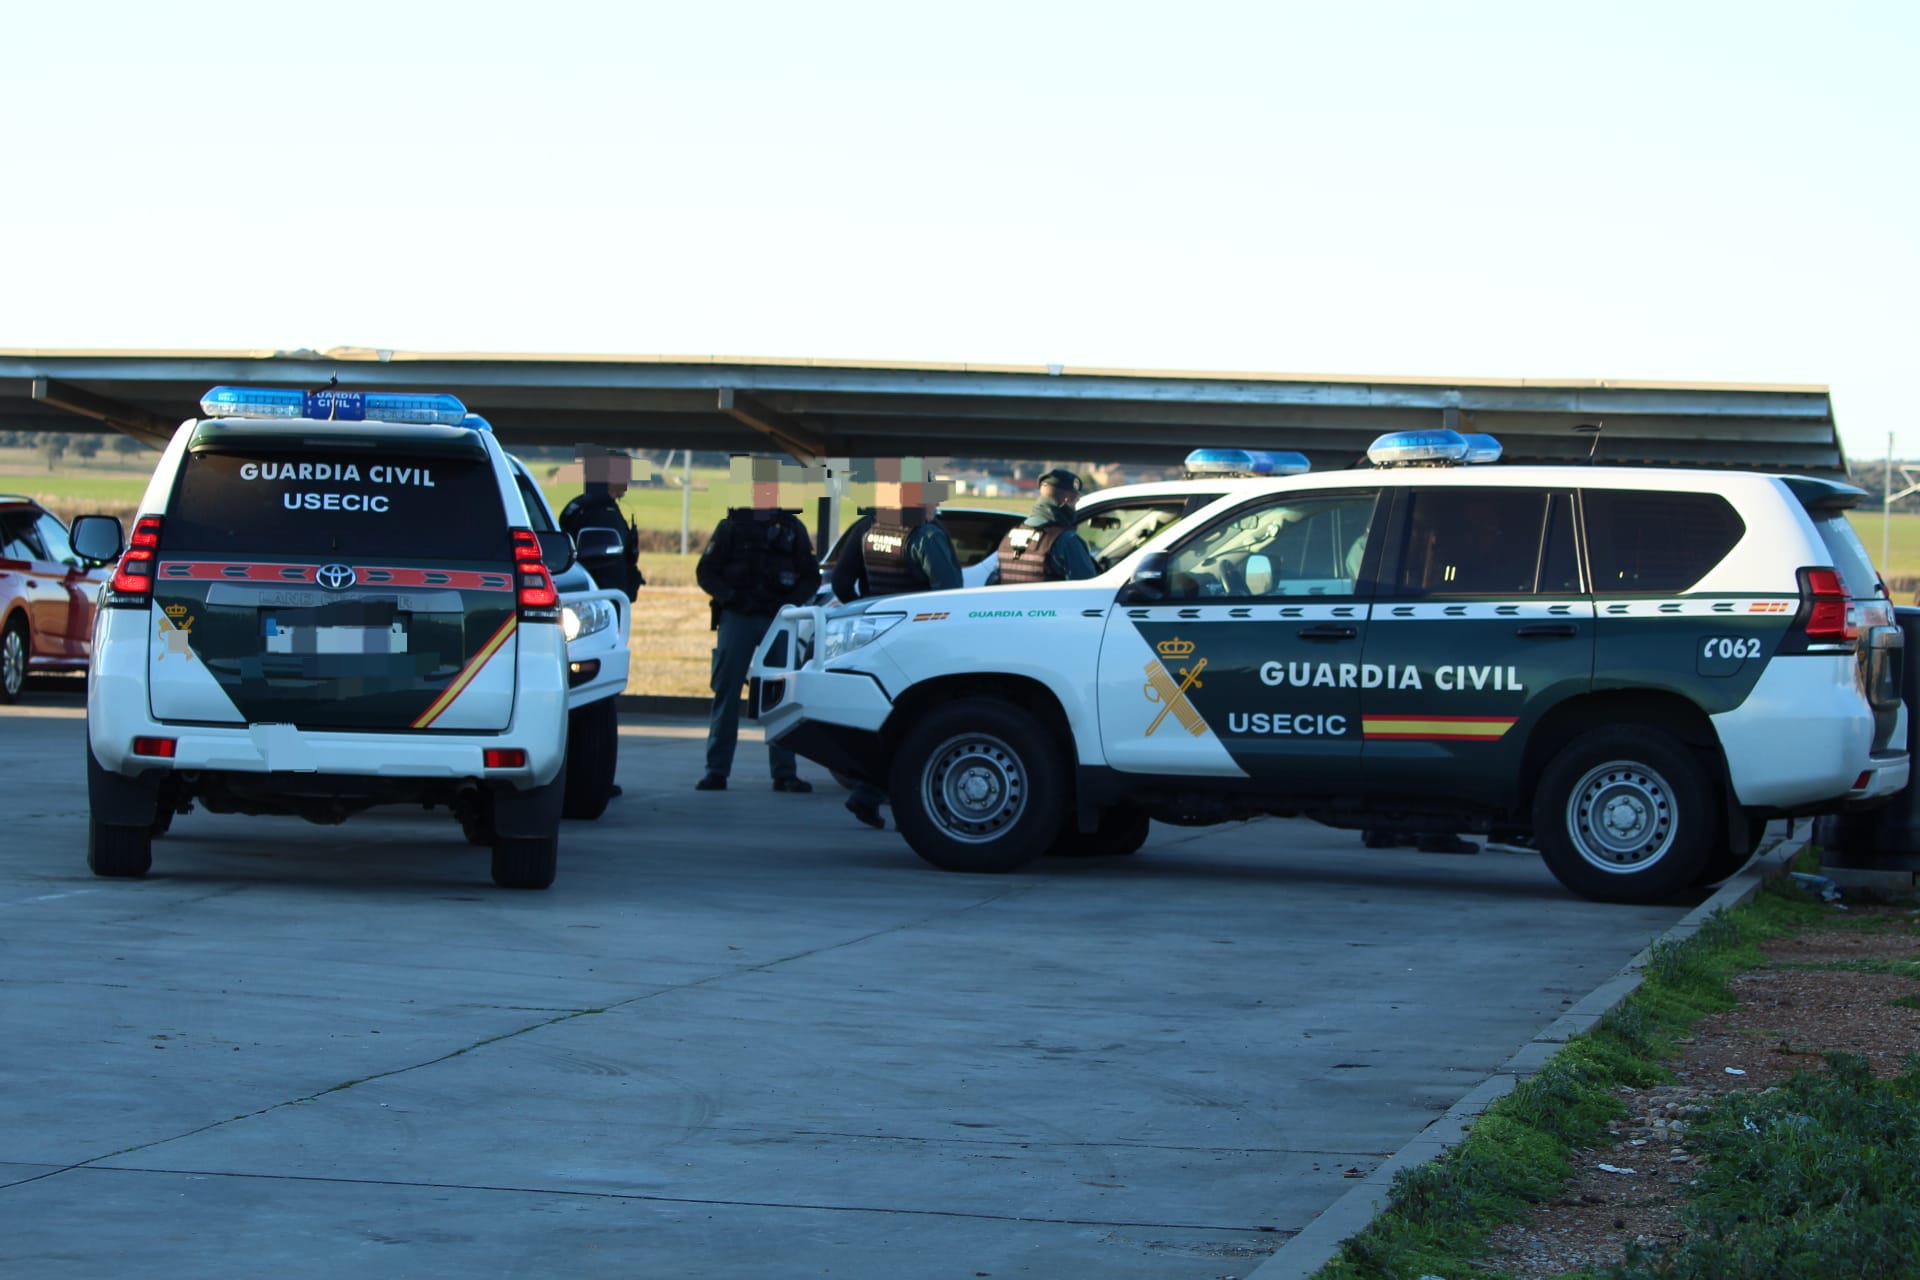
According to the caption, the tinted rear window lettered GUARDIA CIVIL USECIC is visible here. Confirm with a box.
[163,441,511,560]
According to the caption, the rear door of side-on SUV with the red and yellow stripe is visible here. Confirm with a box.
[1361,486,1594,806]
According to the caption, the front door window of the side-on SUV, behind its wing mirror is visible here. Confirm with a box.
[1167,493,1375,599]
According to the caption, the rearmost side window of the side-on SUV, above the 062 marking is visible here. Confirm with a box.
[1580,489,1747,595]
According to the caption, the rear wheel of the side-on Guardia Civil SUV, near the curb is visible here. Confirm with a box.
[1534,725,1722,902]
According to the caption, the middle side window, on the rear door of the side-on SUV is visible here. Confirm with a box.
[1390,487,1580,595]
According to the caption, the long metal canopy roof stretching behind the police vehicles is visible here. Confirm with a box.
[0,347,1847,474]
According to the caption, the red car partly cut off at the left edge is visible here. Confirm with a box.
[0,493,113,702]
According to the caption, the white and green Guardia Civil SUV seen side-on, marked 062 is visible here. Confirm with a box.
[753,432,1908,902]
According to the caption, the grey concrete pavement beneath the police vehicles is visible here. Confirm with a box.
[0,693,1688,1280]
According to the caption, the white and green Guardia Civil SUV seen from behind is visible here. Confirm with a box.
[73,388,572,889]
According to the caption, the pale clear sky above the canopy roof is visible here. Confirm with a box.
[0,0,1920,462]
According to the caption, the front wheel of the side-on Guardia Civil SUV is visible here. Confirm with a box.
[891,699,1066,873]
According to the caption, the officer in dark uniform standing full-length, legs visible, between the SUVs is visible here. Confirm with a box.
[693,498,820,791]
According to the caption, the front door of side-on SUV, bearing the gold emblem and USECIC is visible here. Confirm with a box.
[1098,487,1379,794]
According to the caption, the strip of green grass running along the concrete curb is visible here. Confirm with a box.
[1317,889,1843,1280]
